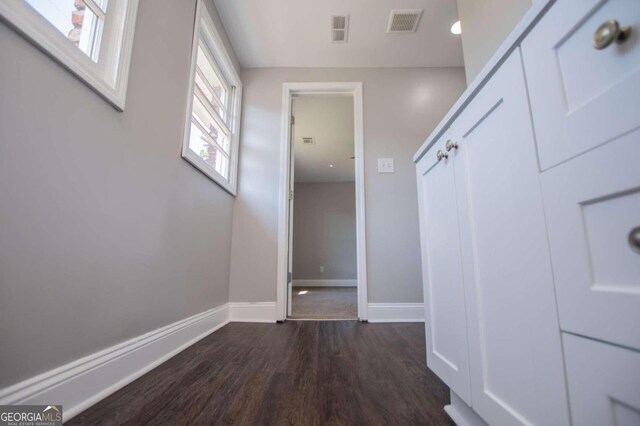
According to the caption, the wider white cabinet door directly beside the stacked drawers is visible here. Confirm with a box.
[452,50,569,426]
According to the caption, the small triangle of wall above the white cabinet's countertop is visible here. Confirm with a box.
[458,0,540,84]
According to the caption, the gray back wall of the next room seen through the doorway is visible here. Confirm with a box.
[293,182,357,280]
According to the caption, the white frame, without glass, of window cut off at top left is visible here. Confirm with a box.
[0,0,138,111]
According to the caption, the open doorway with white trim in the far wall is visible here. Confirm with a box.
[276,83,367,320]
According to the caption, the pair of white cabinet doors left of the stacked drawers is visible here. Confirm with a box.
[417,50,569,425]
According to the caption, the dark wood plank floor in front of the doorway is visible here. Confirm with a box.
[69,321,451,425]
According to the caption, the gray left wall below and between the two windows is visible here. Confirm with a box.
[0,0,239,388]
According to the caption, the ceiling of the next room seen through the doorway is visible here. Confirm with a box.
[294,95,355,182]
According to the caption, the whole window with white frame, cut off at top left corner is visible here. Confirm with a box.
[0,0,138,111]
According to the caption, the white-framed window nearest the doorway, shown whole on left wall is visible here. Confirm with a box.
[182,0,242,195]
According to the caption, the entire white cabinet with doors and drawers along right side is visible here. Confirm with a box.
[415,0,640,426]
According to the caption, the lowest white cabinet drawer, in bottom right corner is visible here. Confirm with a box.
[564,334,640,426]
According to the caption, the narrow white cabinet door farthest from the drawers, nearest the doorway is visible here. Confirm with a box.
[417,131,471,404]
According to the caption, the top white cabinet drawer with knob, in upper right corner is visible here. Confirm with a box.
[522,0,640,170]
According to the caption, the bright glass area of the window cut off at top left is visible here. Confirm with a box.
[23,0,107,62]
